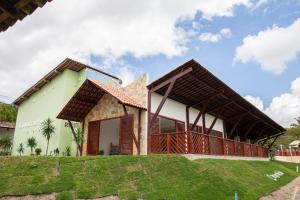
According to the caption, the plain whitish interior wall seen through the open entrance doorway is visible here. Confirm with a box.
[99,118,120,155]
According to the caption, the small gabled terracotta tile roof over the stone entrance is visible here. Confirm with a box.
[57,79,146,122]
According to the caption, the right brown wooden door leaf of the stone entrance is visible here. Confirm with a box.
[119,115,134,154]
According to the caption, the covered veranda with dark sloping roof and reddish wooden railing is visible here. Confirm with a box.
[148,60,285,157]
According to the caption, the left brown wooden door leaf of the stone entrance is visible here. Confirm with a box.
[87,121,100,155]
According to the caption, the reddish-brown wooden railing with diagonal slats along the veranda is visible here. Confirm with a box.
[149,132,268,157]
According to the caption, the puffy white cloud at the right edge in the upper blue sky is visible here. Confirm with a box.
[234,19,300,74]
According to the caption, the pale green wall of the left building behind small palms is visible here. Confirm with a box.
[12,69,86,155]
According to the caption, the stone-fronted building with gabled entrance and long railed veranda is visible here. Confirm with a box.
[57,60,285,157]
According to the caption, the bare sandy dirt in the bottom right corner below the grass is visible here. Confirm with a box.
[260,177,300,200]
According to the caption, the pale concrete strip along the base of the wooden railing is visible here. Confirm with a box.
[182,154,269,161]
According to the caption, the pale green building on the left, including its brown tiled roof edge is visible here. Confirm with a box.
[12,59,121,155]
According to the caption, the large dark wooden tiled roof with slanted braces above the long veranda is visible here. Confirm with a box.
[148,60,285,145]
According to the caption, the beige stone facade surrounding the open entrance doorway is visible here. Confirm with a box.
[83,74,148,155]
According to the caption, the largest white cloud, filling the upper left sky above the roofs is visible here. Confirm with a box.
[0,0,253,97]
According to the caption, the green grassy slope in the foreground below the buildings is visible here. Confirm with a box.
[0,155,297,200]
